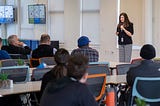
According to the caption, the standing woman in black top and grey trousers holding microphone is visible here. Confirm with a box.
[116,13,134,62]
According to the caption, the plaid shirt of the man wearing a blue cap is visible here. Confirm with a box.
[71,47,99,62]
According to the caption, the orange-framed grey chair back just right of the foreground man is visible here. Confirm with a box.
[86,74,106,101]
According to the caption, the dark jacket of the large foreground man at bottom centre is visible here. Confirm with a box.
[40,77,98,106]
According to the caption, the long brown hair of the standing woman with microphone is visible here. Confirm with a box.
[117,12,132,28]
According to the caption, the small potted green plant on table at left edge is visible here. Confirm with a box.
[0,73,12,89]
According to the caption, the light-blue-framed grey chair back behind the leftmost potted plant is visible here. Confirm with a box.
[0,66,30,83]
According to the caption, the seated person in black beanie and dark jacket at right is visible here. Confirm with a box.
[127,44,160,106]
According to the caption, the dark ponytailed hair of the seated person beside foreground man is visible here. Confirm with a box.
[51,48,69,80]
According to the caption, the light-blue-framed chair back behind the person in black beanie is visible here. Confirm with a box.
[131,77,160,105]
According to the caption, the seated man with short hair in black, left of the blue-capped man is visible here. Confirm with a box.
[32,34,57,58]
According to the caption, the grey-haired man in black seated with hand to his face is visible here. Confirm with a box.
[2,35,31,58]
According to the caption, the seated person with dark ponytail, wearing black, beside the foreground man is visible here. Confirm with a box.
[40,48,69,100]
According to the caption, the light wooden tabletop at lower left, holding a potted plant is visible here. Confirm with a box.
[0,81,41,97]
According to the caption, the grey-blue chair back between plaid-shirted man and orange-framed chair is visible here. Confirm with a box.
[87,64,111,75]
